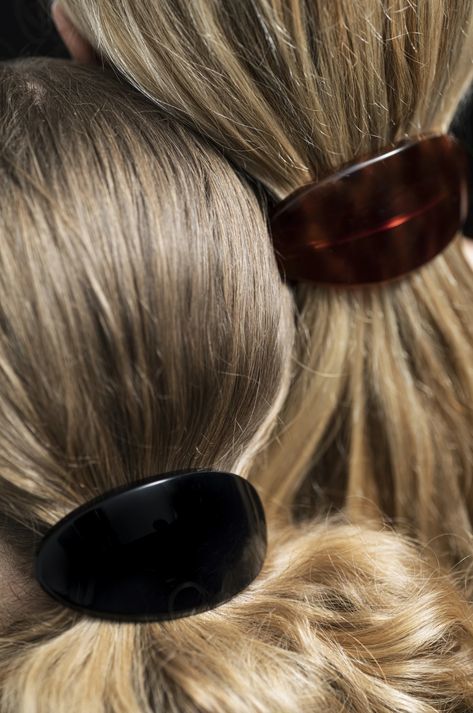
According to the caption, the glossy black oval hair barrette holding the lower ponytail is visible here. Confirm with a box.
[36,470,266,622]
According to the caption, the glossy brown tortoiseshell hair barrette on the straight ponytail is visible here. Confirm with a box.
[271,136,468,286]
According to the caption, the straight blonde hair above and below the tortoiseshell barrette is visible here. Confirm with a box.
[61,0,473,568]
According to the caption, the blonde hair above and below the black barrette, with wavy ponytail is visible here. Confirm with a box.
[0,61,473,713]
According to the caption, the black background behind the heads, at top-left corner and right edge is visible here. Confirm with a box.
[0,0,473,236]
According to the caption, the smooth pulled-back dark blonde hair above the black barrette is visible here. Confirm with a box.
[0,55,294,523]
